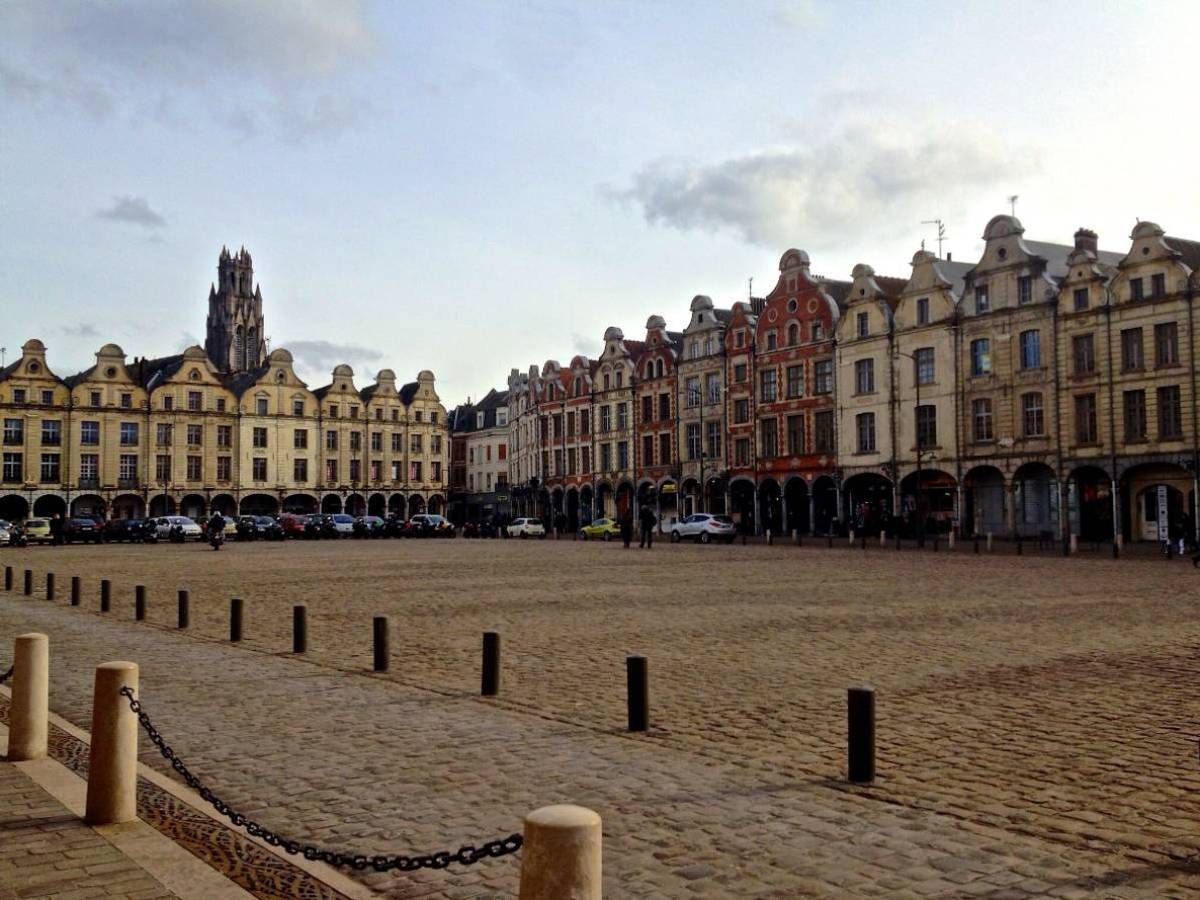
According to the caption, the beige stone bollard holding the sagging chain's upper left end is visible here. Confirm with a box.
[84,662,138,824]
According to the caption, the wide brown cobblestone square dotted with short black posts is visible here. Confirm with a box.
[0,541,1200,898]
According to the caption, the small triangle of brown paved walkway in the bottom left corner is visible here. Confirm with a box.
[0,763,175,900]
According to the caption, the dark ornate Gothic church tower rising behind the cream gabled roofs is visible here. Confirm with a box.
[204,247,266,372]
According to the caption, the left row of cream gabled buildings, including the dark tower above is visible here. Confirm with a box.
[0,248,449,528]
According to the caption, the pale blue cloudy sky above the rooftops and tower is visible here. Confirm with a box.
[0,0,1200,406]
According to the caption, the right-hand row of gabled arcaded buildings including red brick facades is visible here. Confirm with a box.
[492,215,1200,541]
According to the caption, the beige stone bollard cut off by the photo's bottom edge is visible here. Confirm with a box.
[517,805,602,900]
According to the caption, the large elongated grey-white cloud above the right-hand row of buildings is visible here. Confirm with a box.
[601,122,1036,247]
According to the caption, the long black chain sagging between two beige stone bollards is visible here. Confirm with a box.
[120,686,524,872]
